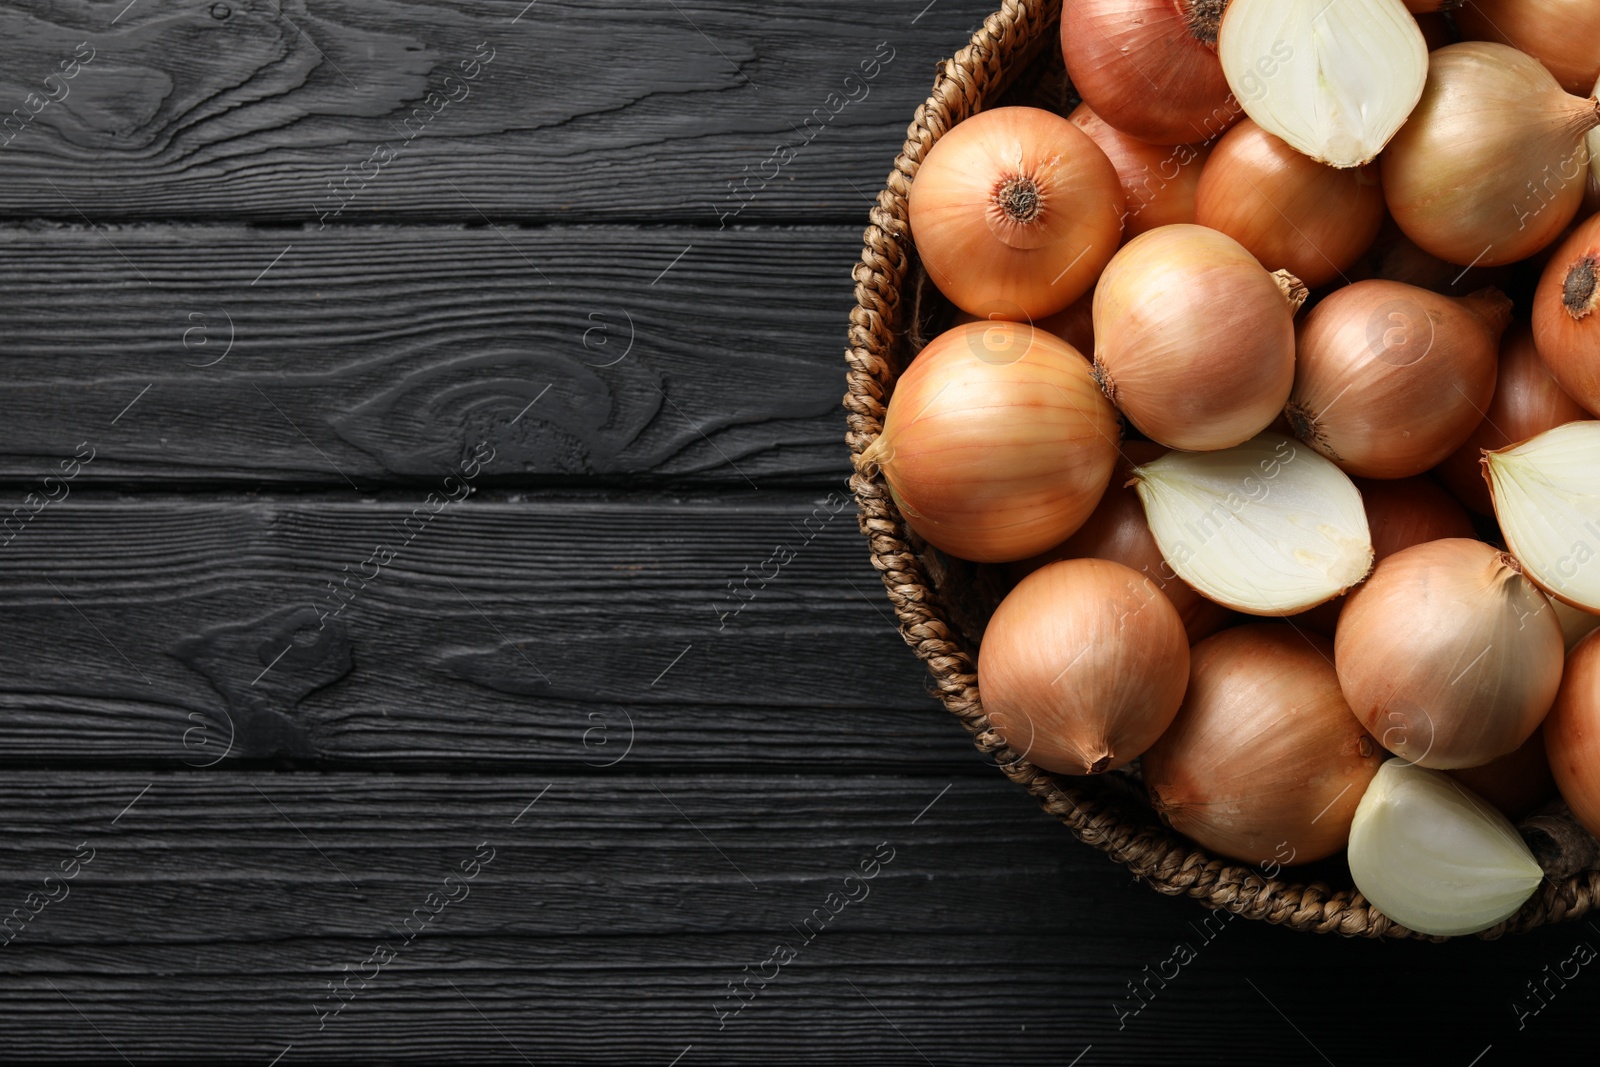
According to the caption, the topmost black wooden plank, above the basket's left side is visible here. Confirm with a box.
[0,0,995,227]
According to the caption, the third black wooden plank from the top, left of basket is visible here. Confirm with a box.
[0,483,978,769]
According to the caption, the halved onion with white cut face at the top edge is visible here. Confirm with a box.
[1218,0,1427,166]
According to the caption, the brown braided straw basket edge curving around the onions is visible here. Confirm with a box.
[845,0,1600,941]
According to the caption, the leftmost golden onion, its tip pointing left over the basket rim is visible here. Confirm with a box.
[862,322,1120,563]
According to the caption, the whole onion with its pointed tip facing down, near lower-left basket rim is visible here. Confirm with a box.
[978,560,1189,774]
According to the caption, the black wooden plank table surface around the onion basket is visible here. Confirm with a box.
[0,0,1600,1067]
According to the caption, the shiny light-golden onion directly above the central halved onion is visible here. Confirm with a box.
[1094,226,1306,451]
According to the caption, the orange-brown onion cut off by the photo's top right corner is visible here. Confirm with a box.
[1456,0,1600,94]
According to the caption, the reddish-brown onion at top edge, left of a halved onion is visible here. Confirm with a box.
[1061,0,1242,144]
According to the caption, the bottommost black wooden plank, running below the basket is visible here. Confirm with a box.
[0,773,1594,1067]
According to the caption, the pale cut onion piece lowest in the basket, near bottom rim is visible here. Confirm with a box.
[1349,760,1544,937]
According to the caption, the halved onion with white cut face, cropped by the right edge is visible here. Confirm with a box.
[1483,421,1600,613]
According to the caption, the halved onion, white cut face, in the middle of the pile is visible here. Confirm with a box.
[1133,434,1373,614]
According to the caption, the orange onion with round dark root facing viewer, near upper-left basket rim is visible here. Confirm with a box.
[909,107,1123,320]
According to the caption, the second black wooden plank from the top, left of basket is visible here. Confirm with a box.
[0,226,861,489]
